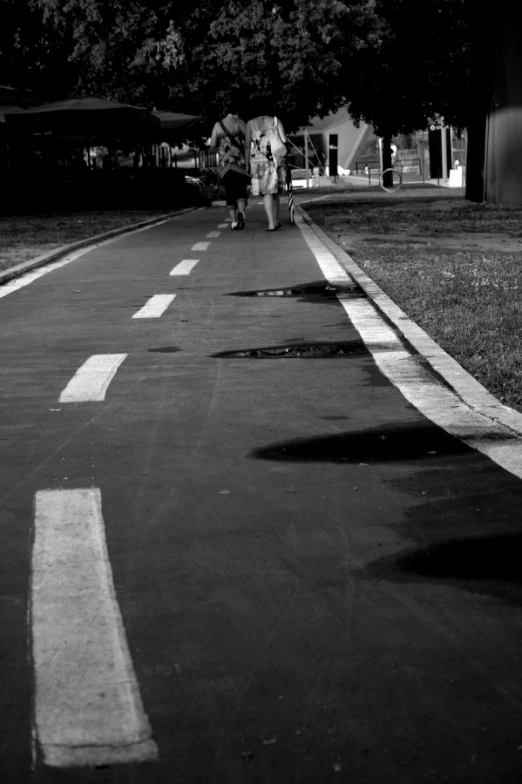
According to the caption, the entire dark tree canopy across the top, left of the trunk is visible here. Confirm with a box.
[0,0,472,135]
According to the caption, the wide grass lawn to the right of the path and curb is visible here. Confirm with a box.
[305,194,522,411]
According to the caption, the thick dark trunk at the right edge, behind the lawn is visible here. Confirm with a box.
[466,0,522,206]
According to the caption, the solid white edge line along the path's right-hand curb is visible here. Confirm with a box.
[296,214,522,479]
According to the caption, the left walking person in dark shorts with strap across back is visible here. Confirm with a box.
[210,104,248,231]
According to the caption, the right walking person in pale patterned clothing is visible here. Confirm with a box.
[245,114,286,231]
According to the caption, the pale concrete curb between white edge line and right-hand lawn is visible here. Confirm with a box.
[296,205,522,435]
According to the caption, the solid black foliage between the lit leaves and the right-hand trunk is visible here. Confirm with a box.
[344,0,472,136]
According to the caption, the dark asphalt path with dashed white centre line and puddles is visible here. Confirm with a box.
[0,205,522,784]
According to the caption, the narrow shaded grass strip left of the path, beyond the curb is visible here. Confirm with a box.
[0,208,175,271]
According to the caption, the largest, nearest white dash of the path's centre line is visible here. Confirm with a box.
[30,487,158,768]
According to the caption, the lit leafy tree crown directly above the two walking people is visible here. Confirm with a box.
[201,0,379,130]
